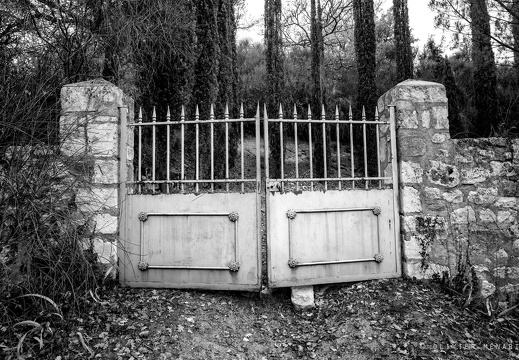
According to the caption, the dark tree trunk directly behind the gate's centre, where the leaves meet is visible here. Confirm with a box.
[265,0,284,177]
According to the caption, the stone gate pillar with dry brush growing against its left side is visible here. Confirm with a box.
[60,79,133,265]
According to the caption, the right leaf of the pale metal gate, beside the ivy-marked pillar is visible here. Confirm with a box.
[264,107,401,287]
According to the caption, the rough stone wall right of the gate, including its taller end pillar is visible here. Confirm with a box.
[378,80,519,296]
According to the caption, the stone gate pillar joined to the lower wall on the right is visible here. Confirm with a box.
[378,80,452,278]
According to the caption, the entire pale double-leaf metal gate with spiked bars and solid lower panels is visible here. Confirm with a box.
[119,102,401,291]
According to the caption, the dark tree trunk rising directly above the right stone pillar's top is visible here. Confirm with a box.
[393,0,413,82]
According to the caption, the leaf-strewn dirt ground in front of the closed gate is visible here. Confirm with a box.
[23,279,519,360]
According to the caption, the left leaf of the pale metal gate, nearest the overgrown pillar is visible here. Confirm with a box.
[119,106,261,290]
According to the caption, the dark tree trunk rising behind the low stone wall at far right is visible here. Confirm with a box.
[469,0,500,137]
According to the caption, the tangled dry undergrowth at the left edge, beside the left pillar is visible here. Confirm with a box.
[0,75,106,359]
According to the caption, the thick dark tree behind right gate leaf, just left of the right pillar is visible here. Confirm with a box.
[353,0,378,175]
